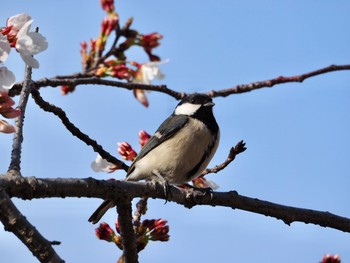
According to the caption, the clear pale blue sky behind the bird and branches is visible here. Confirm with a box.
[0,0,350,263]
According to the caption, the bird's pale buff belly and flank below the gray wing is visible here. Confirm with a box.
[128,118,219,184]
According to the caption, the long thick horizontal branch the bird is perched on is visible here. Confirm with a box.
[0,177,350,233]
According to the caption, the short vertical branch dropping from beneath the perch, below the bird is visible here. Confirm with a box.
[117,198,138,263]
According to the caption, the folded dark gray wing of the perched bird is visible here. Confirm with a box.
[126,115,189,176]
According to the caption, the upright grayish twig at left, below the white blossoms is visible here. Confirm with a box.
[8,65,33,175]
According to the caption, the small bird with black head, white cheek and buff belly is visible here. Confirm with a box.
[89,93,220,224]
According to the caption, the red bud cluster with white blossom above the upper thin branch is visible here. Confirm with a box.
[67,0,168,107]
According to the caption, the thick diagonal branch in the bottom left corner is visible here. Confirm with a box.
[0,187,64,263]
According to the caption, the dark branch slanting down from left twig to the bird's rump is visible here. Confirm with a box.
[32,90,129,171]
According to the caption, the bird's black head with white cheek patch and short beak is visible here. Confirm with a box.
[174,93,215,116]
